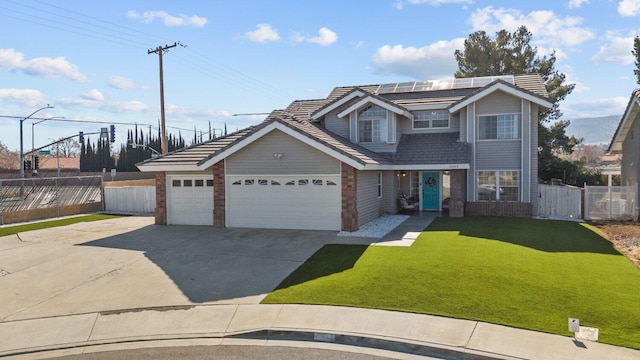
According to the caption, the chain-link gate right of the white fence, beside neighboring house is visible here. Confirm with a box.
[584,185,638,220]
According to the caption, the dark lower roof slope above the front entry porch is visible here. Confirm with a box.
[393,133,471,165]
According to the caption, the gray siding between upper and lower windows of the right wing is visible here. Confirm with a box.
[476,140,522,170]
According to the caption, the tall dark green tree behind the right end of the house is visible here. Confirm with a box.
[454,26,581,180]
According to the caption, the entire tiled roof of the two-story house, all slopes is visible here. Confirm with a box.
[138,75,548,169]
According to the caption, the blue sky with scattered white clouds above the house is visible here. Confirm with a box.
[0,0,640,150]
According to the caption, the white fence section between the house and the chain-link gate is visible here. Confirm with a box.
[538,184,582,220]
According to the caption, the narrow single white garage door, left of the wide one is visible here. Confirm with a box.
[167,175,213,225]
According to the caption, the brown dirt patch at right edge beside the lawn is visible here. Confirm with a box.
[589,221,640,269]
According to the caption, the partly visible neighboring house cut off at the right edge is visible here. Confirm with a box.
[607,89,640,204]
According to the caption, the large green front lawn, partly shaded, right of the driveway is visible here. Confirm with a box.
[263,217,640,349]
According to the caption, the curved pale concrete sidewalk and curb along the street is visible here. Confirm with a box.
[0,305,640,360]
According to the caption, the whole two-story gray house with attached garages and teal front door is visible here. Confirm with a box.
[138,75,553,231]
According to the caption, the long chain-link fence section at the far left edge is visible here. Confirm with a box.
[0,176,103,225]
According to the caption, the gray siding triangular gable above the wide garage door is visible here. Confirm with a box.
[226,130,340,175]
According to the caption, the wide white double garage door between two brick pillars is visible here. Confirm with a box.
[226,175,341,230]
